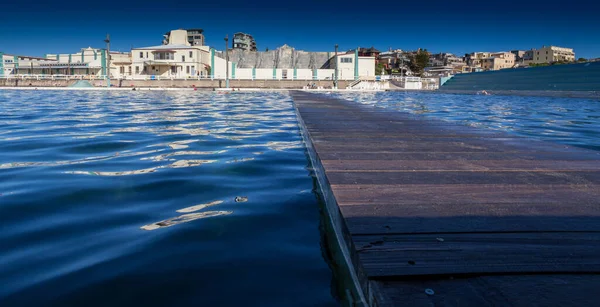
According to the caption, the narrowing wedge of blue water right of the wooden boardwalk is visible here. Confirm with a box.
[331,92,600,150]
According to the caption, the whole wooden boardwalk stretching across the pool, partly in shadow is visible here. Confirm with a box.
[292,92,600,306]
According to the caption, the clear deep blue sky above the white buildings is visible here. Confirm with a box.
[0,0,600,58]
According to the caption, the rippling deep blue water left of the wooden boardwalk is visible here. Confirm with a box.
[0,90,338,306]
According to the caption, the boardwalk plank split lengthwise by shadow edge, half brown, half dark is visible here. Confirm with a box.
[340,205,600,235]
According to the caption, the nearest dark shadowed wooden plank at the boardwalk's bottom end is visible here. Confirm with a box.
[371,274,600,307]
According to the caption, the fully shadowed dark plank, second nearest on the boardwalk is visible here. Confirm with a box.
[354,233,600,278]
